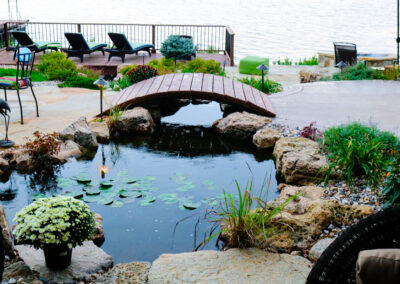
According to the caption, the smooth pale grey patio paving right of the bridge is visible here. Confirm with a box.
[269,80,400,136]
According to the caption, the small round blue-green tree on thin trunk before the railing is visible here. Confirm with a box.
[161,35,194,70]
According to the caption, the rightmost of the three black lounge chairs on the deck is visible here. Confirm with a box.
[106,33,155,62]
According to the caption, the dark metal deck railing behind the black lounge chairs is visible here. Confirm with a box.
[0,21,235,66]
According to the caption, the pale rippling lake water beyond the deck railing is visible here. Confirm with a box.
[0,0,397,62]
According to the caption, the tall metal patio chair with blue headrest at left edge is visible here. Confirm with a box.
[0,47,39,124]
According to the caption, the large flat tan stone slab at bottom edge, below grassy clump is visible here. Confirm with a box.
[148,248,311,284]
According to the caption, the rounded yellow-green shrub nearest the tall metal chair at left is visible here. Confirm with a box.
[38,52,78,81]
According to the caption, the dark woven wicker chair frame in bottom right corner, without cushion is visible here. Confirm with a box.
[307,206,400,284]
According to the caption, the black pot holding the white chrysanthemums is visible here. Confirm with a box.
[43,245,72,270]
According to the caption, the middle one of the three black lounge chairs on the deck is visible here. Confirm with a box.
[63,33,107,62]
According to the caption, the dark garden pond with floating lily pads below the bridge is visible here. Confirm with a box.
[0,103,277,263]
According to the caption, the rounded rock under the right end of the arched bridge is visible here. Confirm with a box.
[213,111,271,140]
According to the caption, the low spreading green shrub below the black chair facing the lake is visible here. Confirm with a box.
[324,63,385,81]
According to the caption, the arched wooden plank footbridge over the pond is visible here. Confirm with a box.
[106,73,275,117]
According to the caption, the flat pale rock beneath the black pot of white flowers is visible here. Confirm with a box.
[15,241,113,283]
